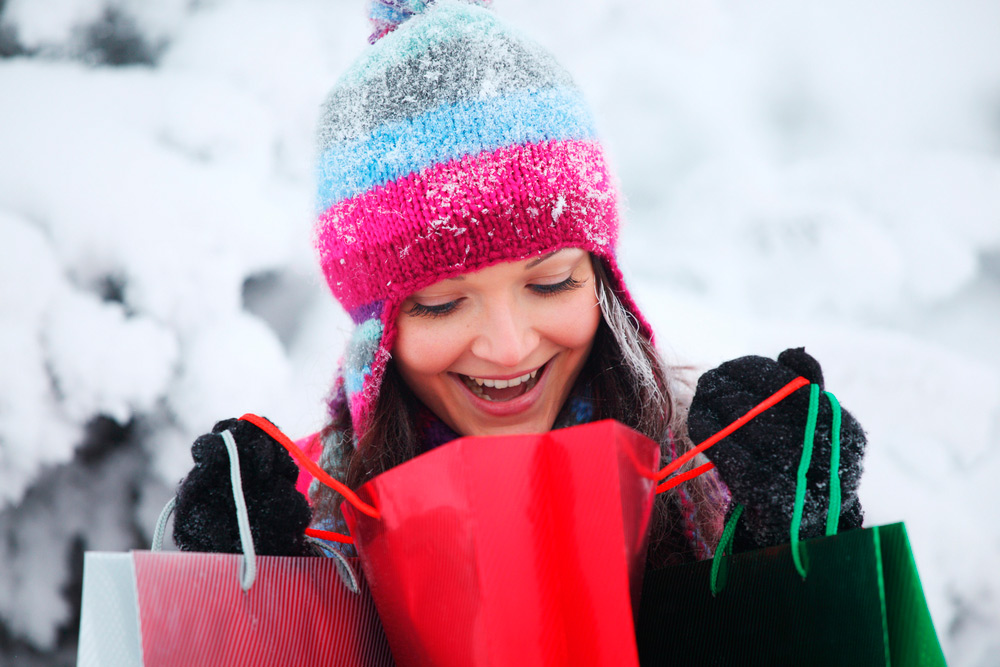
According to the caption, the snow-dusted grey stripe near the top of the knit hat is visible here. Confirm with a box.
[319,35,575,152]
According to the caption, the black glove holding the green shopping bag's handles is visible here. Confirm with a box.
[688,347,865,551]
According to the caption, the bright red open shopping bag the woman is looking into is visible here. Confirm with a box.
[342,420,659,667]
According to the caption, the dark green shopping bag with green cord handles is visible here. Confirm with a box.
[636,385,945,667]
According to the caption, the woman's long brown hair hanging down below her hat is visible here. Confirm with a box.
[311,253,724,567]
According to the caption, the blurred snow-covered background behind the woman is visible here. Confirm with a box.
[0,0,1000,666]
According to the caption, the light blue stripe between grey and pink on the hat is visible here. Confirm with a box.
[317,88,595,211]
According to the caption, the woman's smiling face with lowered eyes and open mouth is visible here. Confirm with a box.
[393,248,601,435]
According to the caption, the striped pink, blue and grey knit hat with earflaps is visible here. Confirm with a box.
[315,0,652,444]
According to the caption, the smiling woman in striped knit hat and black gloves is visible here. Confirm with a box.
[175,0,864,565]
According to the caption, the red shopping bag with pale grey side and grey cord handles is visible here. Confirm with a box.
[77,422,392,667]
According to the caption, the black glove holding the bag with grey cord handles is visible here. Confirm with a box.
[174,419,312,556]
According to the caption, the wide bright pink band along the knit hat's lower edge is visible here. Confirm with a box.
[316,140,618,313]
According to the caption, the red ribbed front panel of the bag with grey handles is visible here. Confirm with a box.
[133,551,391,666]
